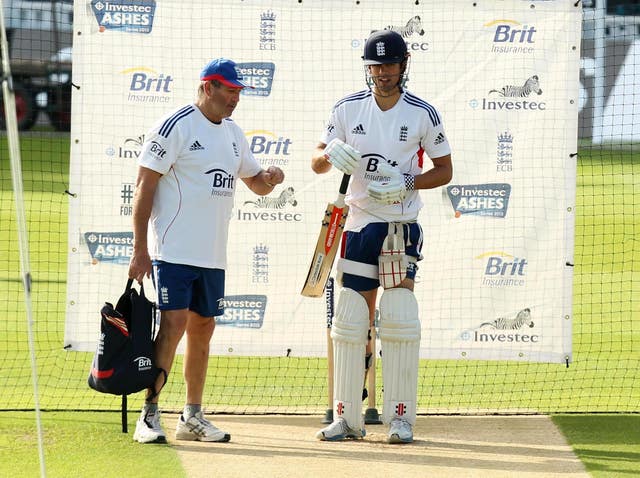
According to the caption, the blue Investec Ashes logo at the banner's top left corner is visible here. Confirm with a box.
[91,0,156,33]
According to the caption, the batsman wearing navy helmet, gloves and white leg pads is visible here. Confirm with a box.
[311,30,453,443]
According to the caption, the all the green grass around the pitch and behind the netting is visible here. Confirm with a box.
[0,133,640,477]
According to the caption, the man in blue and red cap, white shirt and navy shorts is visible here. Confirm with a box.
[129,58,284,443]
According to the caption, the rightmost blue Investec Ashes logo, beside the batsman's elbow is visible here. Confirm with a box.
[447,183,511,217]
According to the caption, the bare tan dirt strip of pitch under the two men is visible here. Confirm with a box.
[163,414,589,478]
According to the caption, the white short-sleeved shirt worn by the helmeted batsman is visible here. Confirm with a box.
[320,90,451,231]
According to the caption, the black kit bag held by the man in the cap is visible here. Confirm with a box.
[88,279,167,433]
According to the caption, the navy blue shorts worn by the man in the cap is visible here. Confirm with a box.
[153,261,225,317]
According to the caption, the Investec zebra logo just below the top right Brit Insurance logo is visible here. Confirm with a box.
[469,75,547,112]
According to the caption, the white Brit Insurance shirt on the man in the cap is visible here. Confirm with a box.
[139,104,261,269]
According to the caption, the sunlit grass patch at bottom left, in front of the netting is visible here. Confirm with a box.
[0,412,186,478]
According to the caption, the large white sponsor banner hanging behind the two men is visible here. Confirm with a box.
[65,0,576,363]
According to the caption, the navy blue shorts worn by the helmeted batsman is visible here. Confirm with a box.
[341,222,423,292]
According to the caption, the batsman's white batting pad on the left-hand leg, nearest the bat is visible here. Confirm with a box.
[331,288,369,430]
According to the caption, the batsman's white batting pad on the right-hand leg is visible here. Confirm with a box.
[379,288,420,425]
